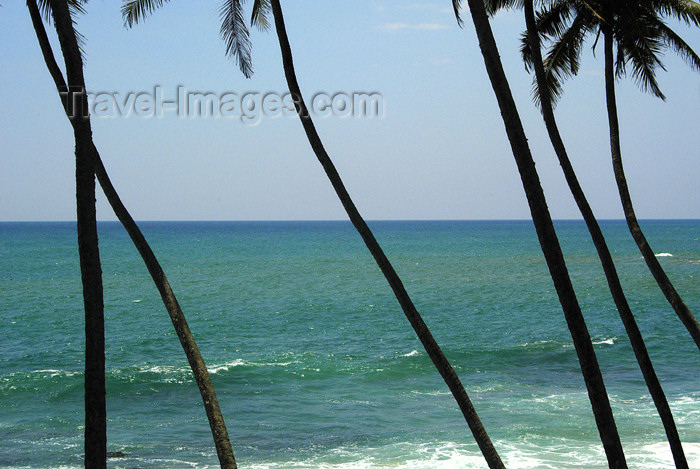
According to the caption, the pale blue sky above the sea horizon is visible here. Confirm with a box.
[0,0,700,221]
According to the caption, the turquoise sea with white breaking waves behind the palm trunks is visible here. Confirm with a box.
[0,221,700,469]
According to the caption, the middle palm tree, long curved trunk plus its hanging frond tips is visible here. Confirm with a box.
[122,0,505,469]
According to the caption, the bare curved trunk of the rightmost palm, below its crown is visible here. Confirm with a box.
[603,27,700,349]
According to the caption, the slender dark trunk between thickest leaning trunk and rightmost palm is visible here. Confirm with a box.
[524,0,688,469]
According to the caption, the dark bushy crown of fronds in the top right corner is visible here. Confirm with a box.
[524,0,700,102]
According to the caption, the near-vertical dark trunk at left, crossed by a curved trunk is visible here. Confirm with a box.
[51,1,107,469]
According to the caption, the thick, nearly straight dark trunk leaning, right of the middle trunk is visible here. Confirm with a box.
[468,0,627,469]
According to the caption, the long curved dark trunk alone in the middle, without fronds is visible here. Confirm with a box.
[271,0,505,469]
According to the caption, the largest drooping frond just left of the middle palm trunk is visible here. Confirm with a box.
[220,0,253,78]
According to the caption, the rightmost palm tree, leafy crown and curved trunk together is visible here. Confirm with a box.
[537,0,700,349]
